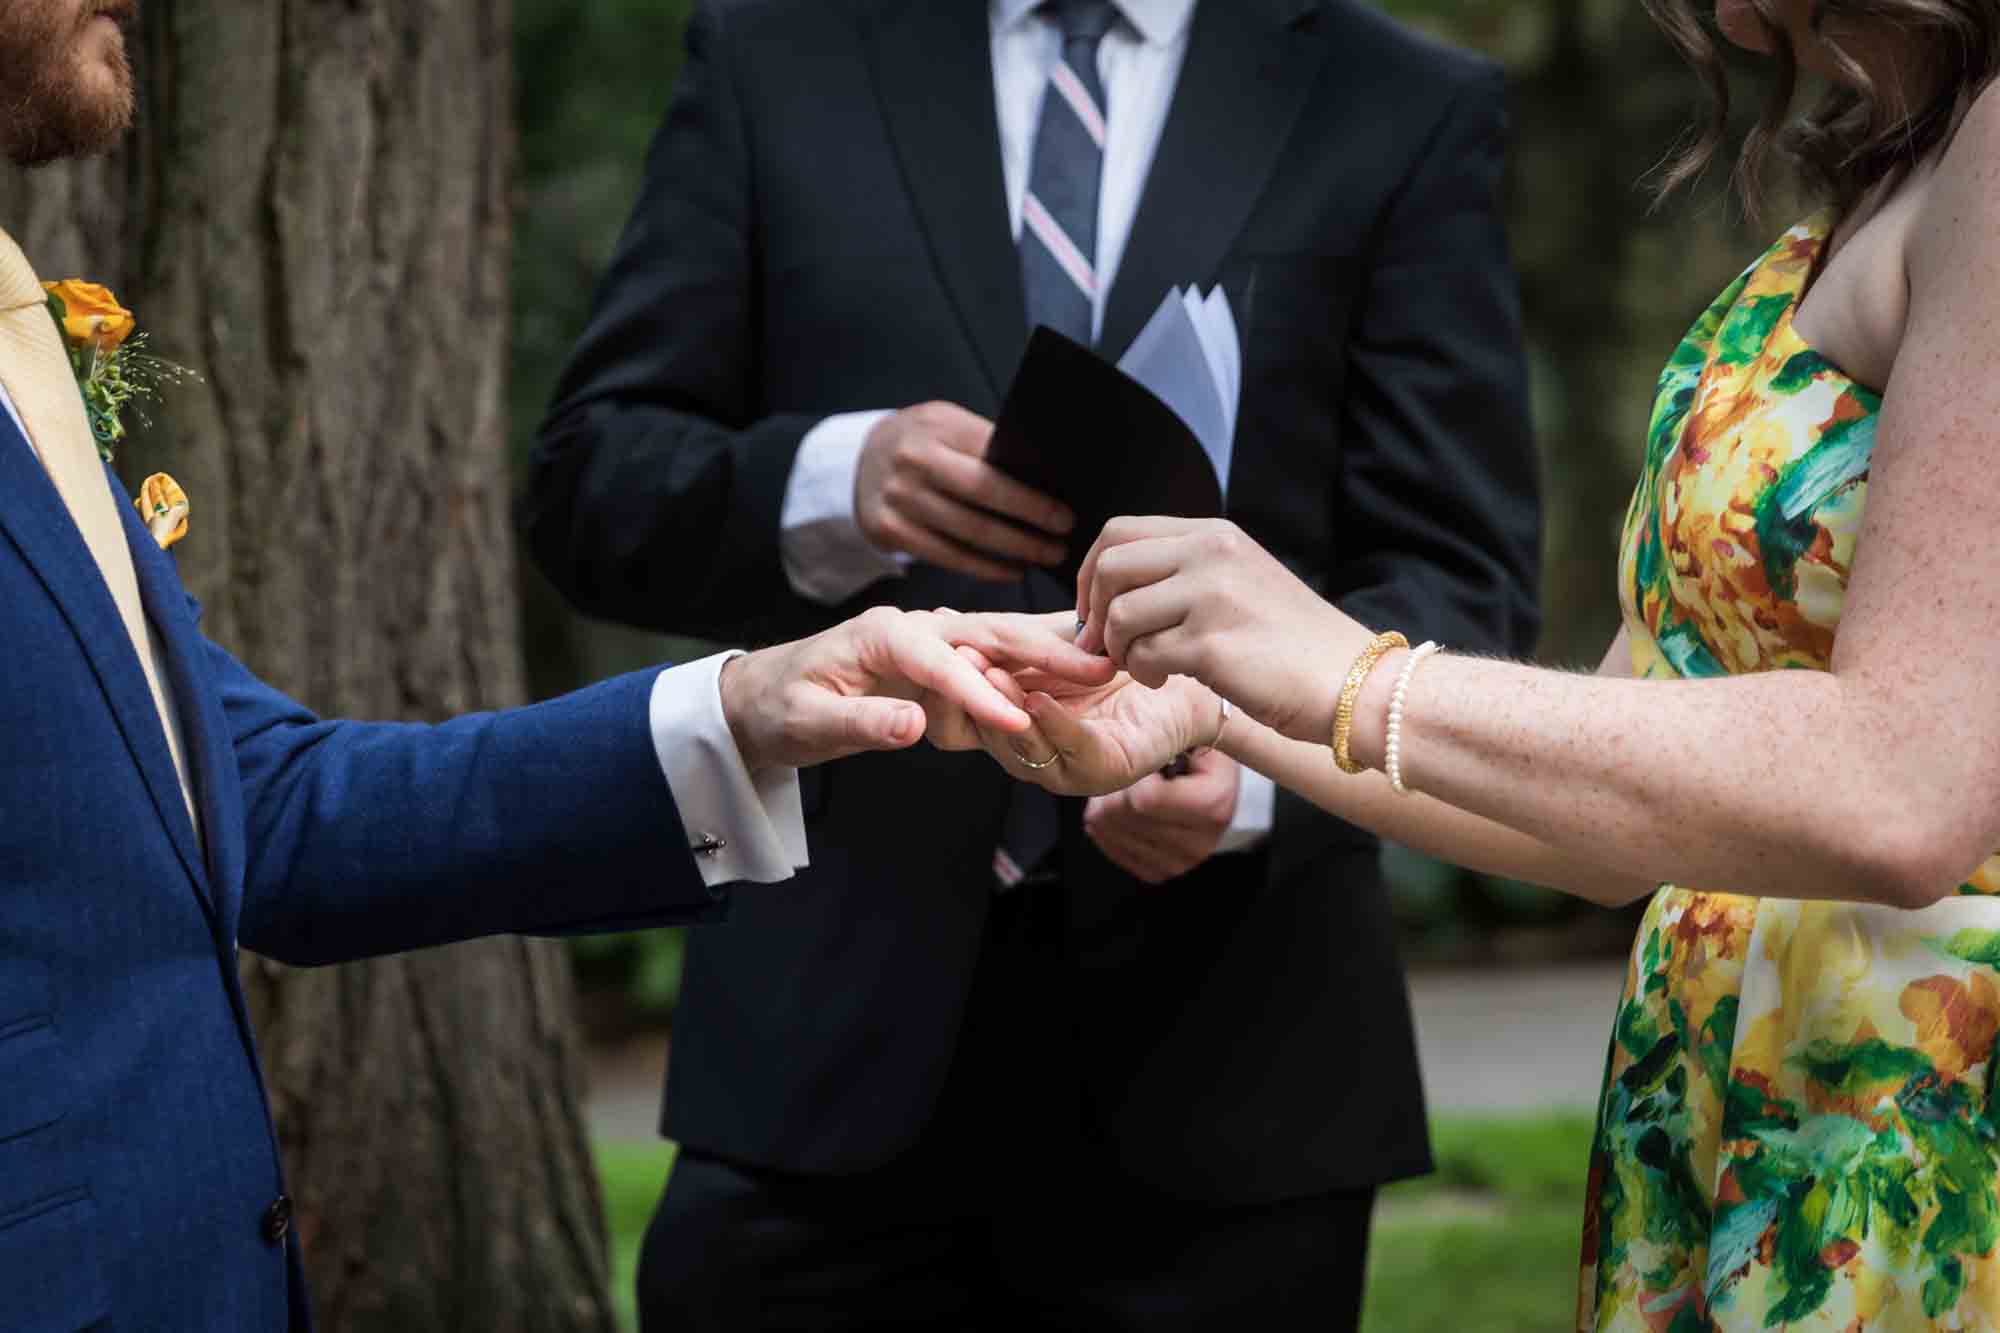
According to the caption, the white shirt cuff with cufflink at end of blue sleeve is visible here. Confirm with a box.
[648,652,808,889]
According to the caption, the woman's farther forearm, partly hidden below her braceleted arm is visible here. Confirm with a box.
[1222,717,1658,907]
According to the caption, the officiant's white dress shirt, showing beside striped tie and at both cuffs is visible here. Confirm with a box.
[778,0,1278,851]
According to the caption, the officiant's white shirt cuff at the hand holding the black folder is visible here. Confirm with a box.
[778,412,910,606]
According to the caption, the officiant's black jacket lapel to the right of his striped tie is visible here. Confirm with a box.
[1096,0,1326,356]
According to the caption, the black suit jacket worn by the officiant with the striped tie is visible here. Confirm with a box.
[522,0,1538,1201]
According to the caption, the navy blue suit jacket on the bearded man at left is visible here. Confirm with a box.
[0,412,724,1333]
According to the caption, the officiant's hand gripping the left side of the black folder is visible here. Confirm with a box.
[854,402,1076,582]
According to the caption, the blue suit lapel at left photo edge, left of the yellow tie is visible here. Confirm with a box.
[0,410,214,909]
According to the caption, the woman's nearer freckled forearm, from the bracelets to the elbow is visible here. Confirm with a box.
[1328,654,1990,907]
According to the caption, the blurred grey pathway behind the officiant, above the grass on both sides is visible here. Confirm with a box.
[588,963,1624,1139]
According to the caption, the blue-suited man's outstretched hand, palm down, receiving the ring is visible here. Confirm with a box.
[722,606,1114,773]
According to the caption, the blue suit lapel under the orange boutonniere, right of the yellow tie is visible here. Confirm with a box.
[124,480,244,935]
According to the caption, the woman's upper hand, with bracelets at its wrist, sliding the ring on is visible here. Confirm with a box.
[1076,518,1374,745]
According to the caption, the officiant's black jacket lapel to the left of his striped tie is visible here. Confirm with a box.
[866,0,1028,400]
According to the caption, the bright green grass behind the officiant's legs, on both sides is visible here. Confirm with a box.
[596,1115,1590,1333]
